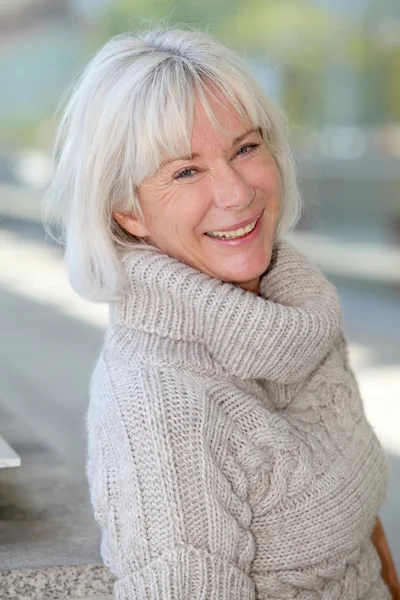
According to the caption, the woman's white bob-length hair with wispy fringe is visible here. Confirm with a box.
[44,28,301,301]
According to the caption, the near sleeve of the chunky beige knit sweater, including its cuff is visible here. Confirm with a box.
[87,360,255,600]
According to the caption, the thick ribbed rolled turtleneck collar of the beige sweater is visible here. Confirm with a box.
[110,242,341,383]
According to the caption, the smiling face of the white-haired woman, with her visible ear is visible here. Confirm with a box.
[114,92,281,291]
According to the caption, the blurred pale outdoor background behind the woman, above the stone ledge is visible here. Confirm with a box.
[0,0,400,580]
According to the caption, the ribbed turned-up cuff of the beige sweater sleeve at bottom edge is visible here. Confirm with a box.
[114,548,256,600]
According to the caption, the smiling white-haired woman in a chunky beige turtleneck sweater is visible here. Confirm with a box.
[45,29,395,600]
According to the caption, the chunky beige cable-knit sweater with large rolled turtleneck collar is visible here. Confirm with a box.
[87,242,390,600]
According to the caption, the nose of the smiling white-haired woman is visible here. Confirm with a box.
[213,161,255,209]
